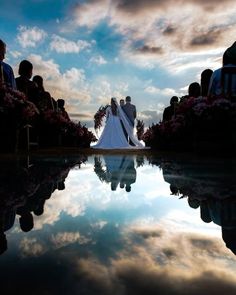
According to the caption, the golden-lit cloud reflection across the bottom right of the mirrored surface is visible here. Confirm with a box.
[73,226,236,295]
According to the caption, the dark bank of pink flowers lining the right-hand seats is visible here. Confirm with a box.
[142,97,236,150]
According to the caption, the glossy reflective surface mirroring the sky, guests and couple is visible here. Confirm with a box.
[0,154,236,295]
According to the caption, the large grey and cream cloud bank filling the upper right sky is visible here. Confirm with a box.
[69,0,236,72]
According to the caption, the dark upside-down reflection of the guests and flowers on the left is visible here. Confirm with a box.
[0,156,87,254]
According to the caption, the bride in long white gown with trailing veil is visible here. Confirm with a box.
[91,97,145,149]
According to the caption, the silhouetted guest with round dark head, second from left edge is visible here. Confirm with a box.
[16,60,37,104]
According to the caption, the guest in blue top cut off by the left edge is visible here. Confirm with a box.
[0,40,16,89]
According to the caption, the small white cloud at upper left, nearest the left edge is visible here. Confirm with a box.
[17,26,47,48]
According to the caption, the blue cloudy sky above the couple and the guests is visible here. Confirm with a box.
[0,0,236,127]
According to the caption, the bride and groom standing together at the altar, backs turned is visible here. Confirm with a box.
[92,96,145,149]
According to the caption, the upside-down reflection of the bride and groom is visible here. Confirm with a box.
[94,155,140,192]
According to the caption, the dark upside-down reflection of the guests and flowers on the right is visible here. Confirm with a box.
[154,160,236,255]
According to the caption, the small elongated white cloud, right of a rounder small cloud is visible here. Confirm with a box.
[50,35,91,53]
